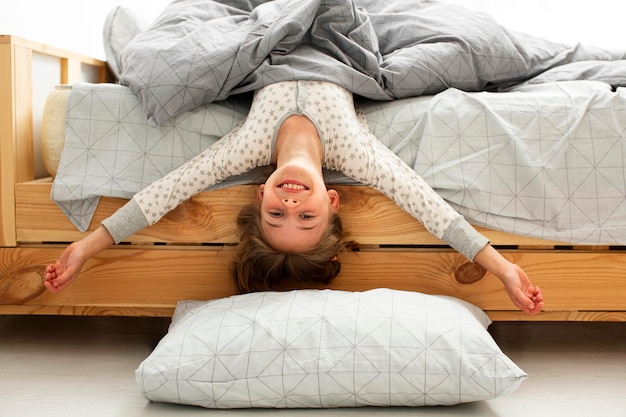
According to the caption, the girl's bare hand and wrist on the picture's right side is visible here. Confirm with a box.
[474,245,543,314]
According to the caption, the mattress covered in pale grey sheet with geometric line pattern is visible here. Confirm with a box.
[43,81,626,244]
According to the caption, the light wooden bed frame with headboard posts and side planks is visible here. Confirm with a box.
[0,36,626,321]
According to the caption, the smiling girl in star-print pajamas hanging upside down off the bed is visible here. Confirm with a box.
[45,81,543,314]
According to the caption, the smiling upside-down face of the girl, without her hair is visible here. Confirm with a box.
[258,164,339,253]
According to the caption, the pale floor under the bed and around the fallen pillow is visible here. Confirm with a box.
[0,316,626,417]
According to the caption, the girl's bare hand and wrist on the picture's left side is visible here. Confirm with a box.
[44,226,113,292]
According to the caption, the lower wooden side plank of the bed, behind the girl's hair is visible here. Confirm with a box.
[0,245,626,320]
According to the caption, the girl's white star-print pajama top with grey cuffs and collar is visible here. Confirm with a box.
[102,81,488,260]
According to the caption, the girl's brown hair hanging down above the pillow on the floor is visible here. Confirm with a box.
[232,204,349,293]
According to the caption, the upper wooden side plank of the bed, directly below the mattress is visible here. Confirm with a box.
[15,178,557,248]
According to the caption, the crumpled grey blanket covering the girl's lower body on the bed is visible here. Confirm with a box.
[120,0,626,125]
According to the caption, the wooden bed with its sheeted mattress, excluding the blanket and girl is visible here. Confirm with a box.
[0,2,626,321]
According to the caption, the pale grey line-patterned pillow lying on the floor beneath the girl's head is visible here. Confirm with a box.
[136,289,527,408]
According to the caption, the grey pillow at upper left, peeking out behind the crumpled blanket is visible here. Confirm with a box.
[102,6,148,79]
